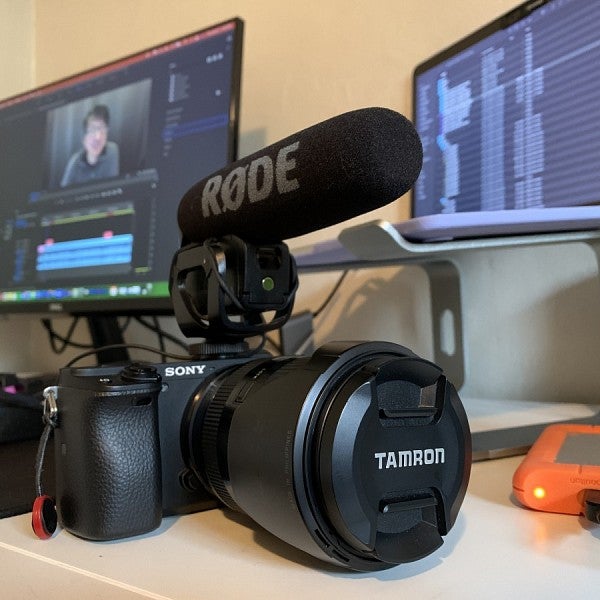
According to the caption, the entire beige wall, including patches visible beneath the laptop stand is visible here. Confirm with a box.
[0,0,600,400]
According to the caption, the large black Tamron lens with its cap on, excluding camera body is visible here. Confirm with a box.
[183,342,471,571]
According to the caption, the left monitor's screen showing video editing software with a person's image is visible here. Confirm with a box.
[0,19,242,310]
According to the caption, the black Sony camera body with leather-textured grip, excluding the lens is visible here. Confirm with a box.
[54,358,249,540]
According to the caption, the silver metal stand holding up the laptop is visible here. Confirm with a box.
[295,220,600,460]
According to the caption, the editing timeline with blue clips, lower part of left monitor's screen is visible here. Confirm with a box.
[0,172,164,301]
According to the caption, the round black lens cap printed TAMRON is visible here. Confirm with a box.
[314,357,470,564]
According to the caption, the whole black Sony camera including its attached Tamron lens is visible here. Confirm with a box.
[54,342,470,571]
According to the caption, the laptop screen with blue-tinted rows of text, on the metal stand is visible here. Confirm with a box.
[413,0,600,216]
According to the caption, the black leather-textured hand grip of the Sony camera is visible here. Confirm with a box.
[54,388,162,541]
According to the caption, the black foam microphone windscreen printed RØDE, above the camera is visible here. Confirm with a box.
[178,108,423,245]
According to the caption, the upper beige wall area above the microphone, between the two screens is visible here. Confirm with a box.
[35,0,512,164]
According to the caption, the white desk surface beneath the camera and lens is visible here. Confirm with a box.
[0,398,600,600]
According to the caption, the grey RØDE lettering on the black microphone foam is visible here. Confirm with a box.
[202,142,300,218]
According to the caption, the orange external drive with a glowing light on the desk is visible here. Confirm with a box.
[513,425,600,515]
